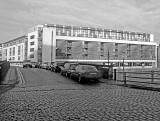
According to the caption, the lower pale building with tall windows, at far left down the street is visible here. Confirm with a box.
[2,36,27,62]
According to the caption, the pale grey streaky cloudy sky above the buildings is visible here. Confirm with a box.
[0,0,160,43]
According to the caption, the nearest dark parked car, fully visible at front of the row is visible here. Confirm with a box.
[70,65,101,83]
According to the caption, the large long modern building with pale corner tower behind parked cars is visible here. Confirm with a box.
[28,24,158,67]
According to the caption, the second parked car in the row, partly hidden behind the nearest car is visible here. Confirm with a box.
[61,63,77,76]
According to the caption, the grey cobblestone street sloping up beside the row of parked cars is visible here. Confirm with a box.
[0,69,160,121]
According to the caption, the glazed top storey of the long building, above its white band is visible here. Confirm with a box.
[56,26,150,42]
